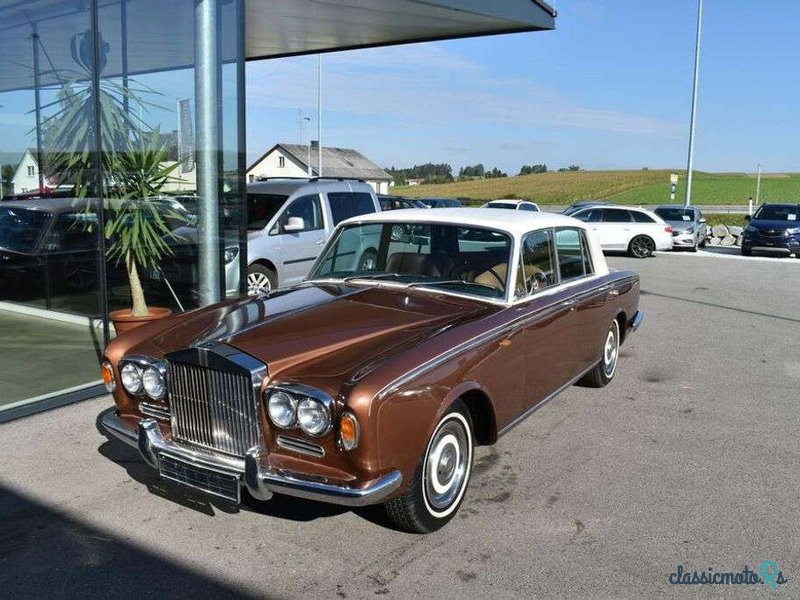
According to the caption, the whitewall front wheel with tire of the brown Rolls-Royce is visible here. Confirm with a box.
[384,401,474,533]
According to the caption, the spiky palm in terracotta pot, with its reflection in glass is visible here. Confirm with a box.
[43,70,188,334]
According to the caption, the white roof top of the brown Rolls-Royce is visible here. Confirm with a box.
[343,208,587,238]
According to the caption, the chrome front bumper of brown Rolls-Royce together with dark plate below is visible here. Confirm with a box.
[100,410,403,507]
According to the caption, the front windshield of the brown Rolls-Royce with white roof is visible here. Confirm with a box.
[309,223,511,298]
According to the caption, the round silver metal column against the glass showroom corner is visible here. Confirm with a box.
[194,0,222,306]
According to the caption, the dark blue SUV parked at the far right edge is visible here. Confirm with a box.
[742,204,800,257]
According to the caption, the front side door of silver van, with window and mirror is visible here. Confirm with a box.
[270,194,326,285]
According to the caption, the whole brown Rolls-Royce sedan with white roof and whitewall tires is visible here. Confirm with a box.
[101,208,642,532]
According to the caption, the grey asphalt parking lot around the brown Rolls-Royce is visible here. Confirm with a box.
[0,254,800,598]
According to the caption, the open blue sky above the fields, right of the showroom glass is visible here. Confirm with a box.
[247,0,800,174]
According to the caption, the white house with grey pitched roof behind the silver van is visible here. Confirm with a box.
[247,144,393,194]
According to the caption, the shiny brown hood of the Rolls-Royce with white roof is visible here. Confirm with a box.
[142,284,498,380]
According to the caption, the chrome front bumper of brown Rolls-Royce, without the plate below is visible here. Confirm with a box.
[100,411,403,507]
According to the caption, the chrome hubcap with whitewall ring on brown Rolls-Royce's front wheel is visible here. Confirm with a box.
[425,420,470,510]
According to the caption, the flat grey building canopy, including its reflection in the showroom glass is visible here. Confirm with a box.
[0,0,555,92]
